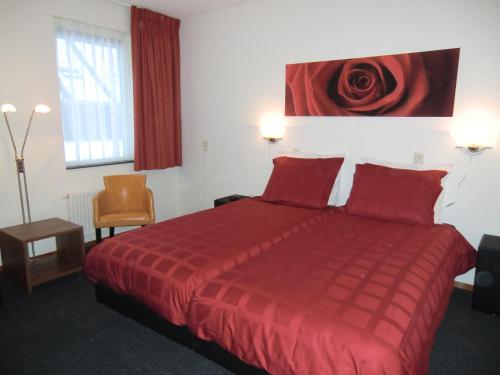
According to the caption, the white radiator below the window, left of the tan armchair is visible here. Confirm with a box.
[64,191,96,241]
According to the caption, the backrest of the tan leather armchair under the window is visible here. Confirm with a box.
[103,174,146,211]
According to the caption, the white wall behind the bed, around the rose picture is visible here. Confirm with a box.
[180,0,500,282]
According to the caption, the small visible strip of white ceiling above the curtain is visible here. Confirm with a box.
[111,0,254,18]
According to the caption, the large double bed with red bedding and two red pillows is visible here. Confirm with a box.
[85,157,476,375]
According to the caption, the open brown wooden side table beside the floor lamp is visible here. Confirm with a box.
[0,218,85,293]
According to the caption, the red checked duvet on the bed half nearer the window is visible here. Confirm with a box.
[85,199,333,325]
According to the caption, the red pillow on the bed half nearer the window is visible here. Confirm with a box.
[262,156,344,208]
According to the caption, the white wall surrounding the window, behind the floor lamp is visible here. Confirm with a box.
[0,0,179,253]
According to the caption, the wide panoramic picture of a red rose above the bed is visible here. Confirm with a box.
[285,48,460,117]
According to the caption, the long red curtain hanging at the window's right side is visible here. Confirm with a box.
[131,6,182,171]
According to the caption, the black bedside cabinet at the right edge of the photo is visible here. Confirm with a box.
[472,234,500,314]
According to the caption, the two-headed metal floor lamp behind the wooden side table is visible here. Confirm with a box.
[0,104,50,259]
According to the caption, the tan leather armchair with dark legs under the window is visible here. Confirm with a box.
[92,174,155,243]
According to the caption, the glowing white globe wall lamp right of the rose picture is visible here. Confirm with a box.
[451,112,498,155]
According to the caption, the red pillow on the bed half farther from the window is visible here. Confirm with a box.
[346,163,447,225]
